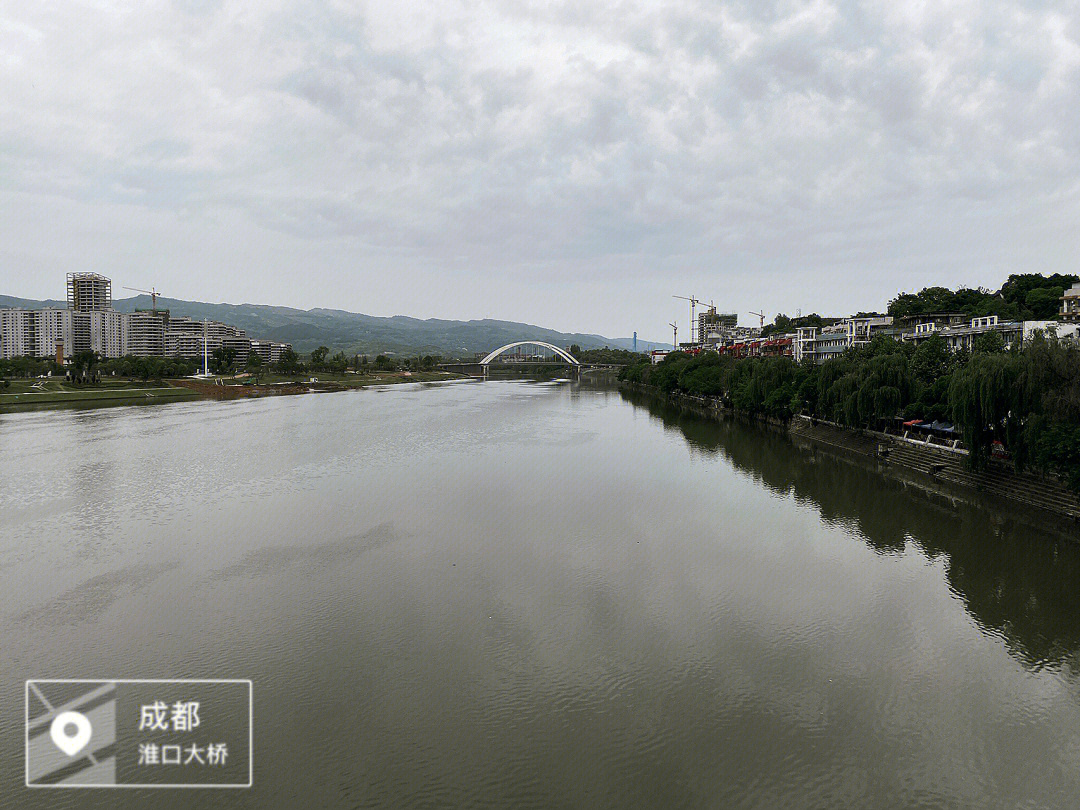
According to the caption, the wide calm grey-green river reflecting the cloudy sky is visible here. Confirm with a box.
[0,381,1080,809]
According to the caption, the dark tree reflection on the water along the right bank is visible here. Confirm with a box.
[623,391,1080,669]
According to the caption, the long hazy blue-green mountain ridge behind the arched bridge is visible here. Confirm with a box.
[0,295,671,357]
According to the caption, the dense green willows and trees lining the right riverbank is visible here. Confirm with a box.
[620,332,1080,491]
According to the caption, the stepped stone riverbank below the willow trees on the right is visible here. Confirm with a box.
[624,383,1080,541]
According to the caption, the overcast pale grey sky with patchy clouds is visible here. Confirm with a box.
[0,0,1080,340]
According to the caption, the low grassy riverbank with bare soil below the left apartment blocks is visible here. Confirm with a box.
[0,372,468,411]
